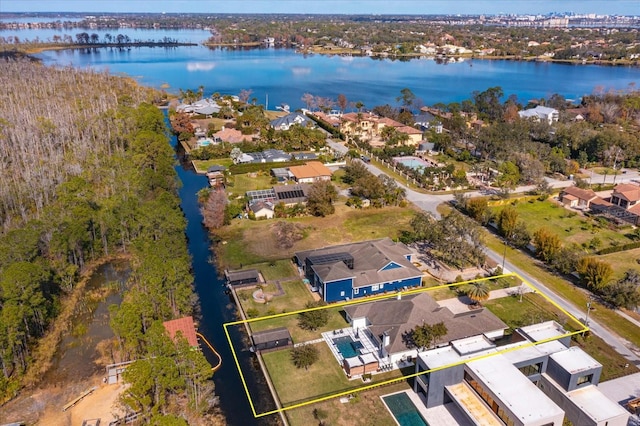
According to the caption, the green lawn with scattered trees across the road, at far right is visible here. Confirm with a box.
[491,200,632,249]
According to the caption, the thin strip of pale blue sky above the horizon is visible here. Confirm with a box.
[0,0,640,15]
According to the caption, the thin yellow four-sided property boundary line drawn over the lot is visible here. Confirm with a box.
[222,273,589,418]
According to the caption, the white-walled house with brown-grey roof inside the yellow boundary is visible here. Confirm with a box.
[345,292,509,364]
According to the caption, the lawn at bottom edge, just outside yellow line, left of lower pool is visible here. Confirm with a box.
[285,382,410,426]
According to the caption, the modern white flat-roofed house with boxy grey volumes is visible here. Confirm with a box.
[414,321,629,426]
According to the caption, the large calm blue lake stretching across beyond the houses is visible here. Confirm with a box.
[30,43,640,109]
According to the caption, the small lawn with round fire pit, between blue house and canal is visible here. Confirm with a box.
[236,280,313,316]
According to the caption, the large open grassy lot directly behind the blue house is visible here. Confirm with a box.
[216,205,415,269]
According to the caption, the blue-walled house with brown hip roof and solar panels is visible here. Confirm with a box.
[294,238,422,302]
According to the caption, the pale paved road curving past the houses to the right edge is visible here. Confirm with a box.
[364,158,640,365]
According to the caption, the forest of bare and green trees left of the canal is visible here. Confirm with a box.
[0,60,216,425]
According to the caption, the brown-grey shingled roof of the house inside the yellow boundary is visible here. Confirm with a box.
[344,292,508,353]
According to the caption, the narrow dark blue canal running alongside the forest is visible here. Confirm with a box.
[172,127,280,426]
